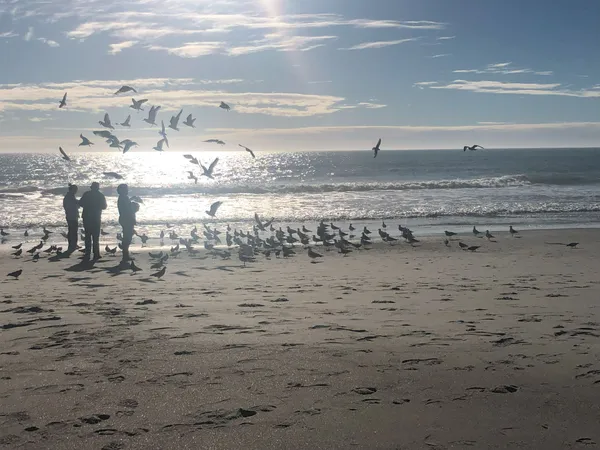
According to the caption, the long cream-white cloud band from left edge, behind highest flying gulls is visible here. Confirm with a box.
[0,78,385,117]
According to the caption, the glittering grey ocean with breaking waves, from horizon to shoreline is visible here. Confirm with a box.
[0,149,600,241]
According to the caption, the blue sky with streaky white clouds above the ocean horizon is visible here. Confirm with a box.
[0,0,600,152]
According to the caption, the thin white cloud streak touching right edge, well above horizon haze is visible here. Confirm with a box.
[414,80,600,98]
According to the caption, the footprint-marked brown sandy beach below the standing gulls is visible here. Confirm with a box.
[0,230,600,450]
